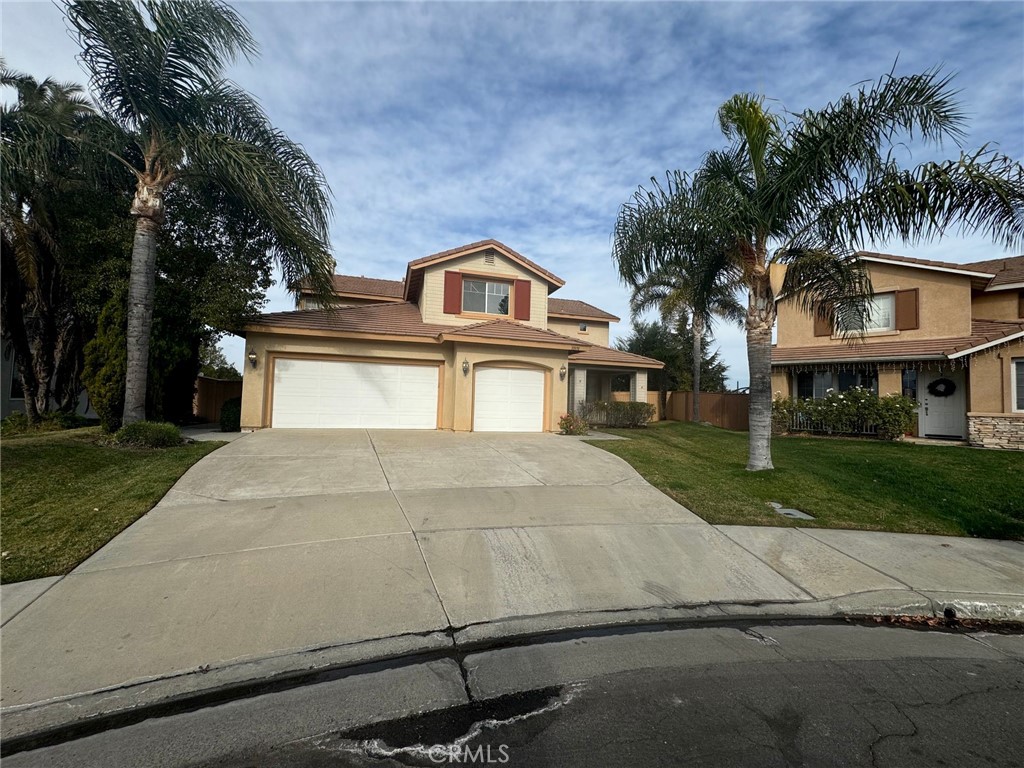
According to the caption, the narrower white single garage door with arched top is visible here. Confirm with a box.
[473,368,544,432]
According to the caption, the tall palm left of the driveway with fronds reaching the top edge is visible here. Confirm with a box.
[63,0,333,424]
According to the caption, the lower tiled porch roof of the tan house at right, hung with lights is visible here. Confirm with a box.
[771,319,1024,366]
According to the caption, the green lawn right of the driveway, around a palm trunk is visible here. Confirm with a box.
[593,422,1024,540]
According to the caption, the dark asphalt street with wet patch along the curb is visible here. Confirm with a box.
[4,623,1024,768]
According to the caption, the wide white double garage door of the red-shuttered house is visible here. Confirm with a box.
[271,358,437,429]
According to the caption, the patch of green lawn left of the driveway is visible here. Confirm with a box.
[0,427,223,583]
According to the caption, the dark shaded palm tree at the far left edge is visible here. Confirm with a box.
[0,61,96,424]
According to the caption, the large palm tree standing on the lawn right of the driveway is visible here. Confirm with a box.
[614,70,1024,470]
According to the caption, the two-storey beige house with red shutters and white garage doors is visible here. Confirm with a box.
[235,240,663,432]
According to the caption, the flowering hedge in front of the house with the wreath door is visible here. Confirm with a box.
[772,387,918,440]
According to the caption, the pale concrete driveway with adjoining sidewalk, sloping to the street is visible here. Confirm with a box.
[2,430,1024,735]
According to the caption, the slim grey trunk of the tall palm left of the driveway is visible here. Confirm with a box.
[122,192,163,424]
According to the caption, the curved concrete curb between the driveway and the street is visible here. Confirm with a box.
[0,590,1024,757]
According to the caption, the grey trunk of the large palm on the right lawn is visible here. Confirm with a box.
[746,272,775,472]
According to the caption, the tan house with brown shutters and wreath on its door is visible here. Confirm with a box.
[772,253,1024,450]
